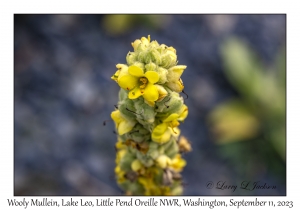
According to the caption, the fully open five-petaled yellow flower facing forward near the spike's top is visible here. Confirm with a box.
[118,65,159,106]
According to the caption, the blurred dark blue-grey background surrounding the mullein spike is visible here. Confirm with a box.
[14,14,286,196]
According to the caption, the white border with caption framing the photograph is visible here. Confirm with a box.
[0,0,300,209]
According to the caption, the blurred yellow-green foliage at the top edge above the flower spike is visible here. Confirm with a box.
[102,14,170,35]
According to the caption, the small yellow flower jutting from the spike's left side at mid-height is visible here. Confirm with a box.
[111,110,136,135]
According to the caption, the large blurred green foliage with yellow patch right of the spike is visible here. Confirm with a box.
[208,38,286,180]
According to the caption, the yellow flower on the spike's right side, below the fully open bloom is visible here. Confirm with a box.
[151,105,188,144]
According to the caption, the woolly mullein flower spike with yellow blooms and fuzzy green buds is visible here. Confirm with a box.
[111,36,191,195]
